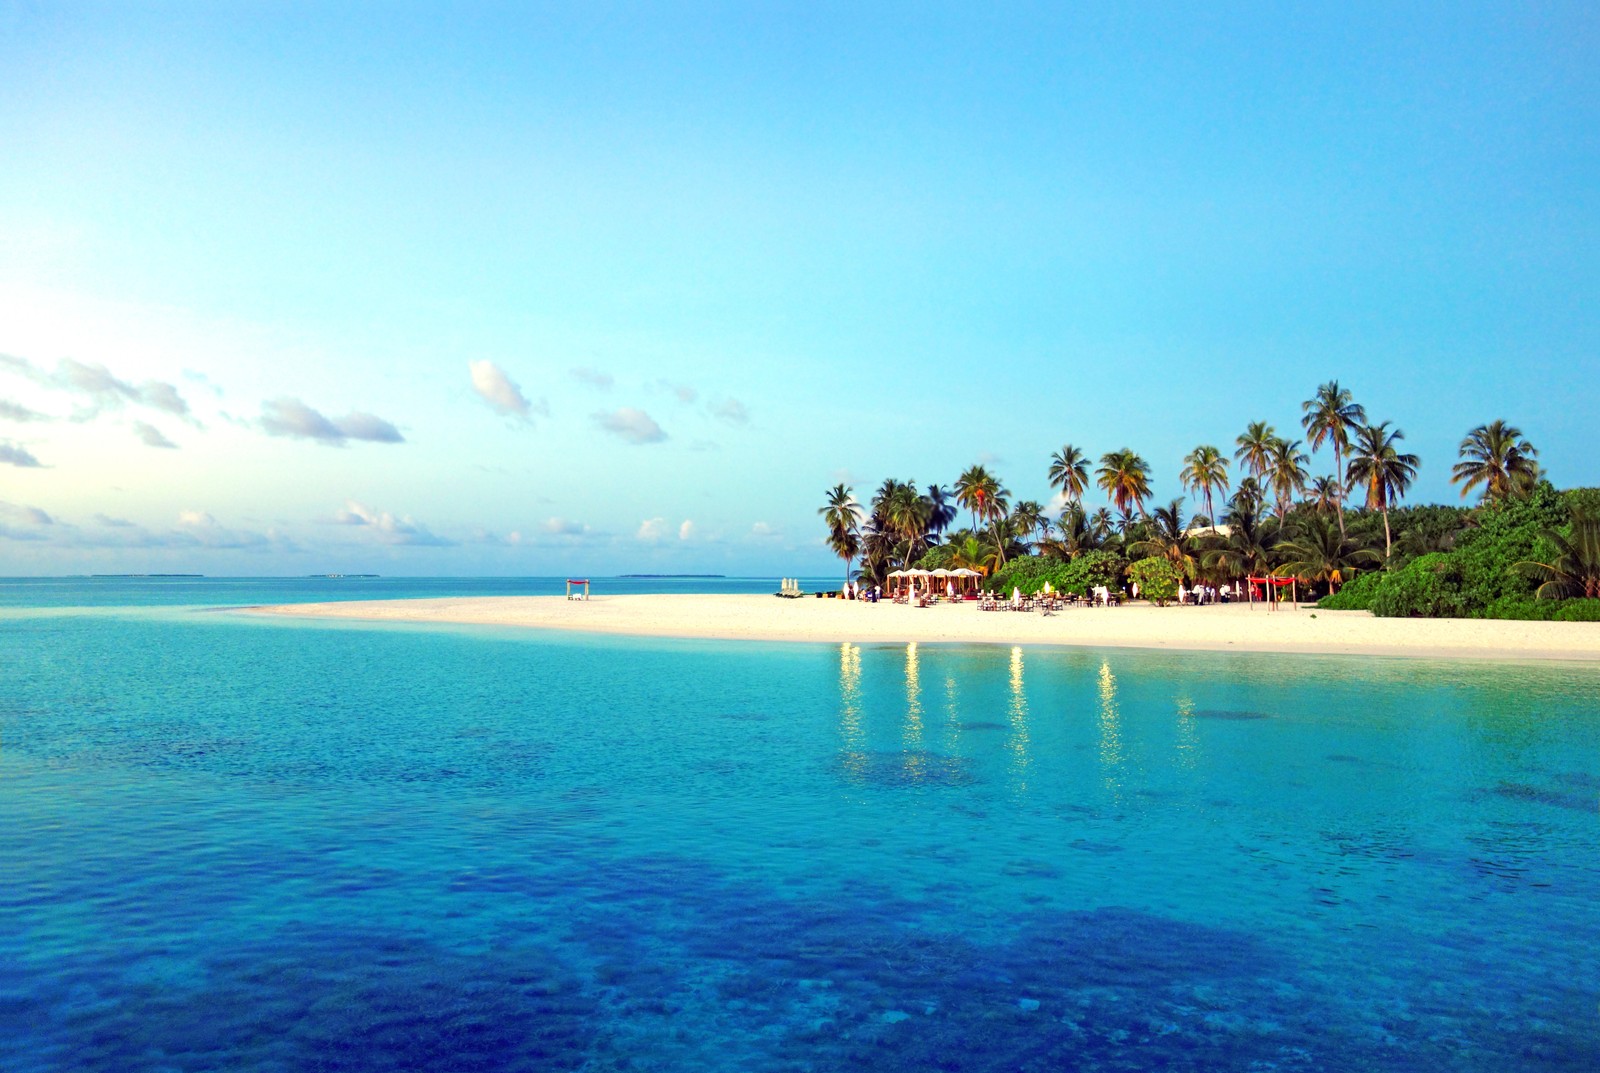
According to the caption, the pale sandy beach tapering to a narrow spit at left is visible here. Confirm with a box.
[248,593,1600,662]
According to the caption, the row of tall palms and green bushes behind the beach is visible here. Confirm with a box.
[819,381,1600,617]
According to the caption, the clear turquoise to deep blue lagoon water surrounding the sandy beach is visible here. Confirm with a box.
[0,580,1600,1073]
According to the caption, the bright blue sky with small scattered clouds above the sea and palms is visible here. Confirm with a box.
[0,0,1600,574]
